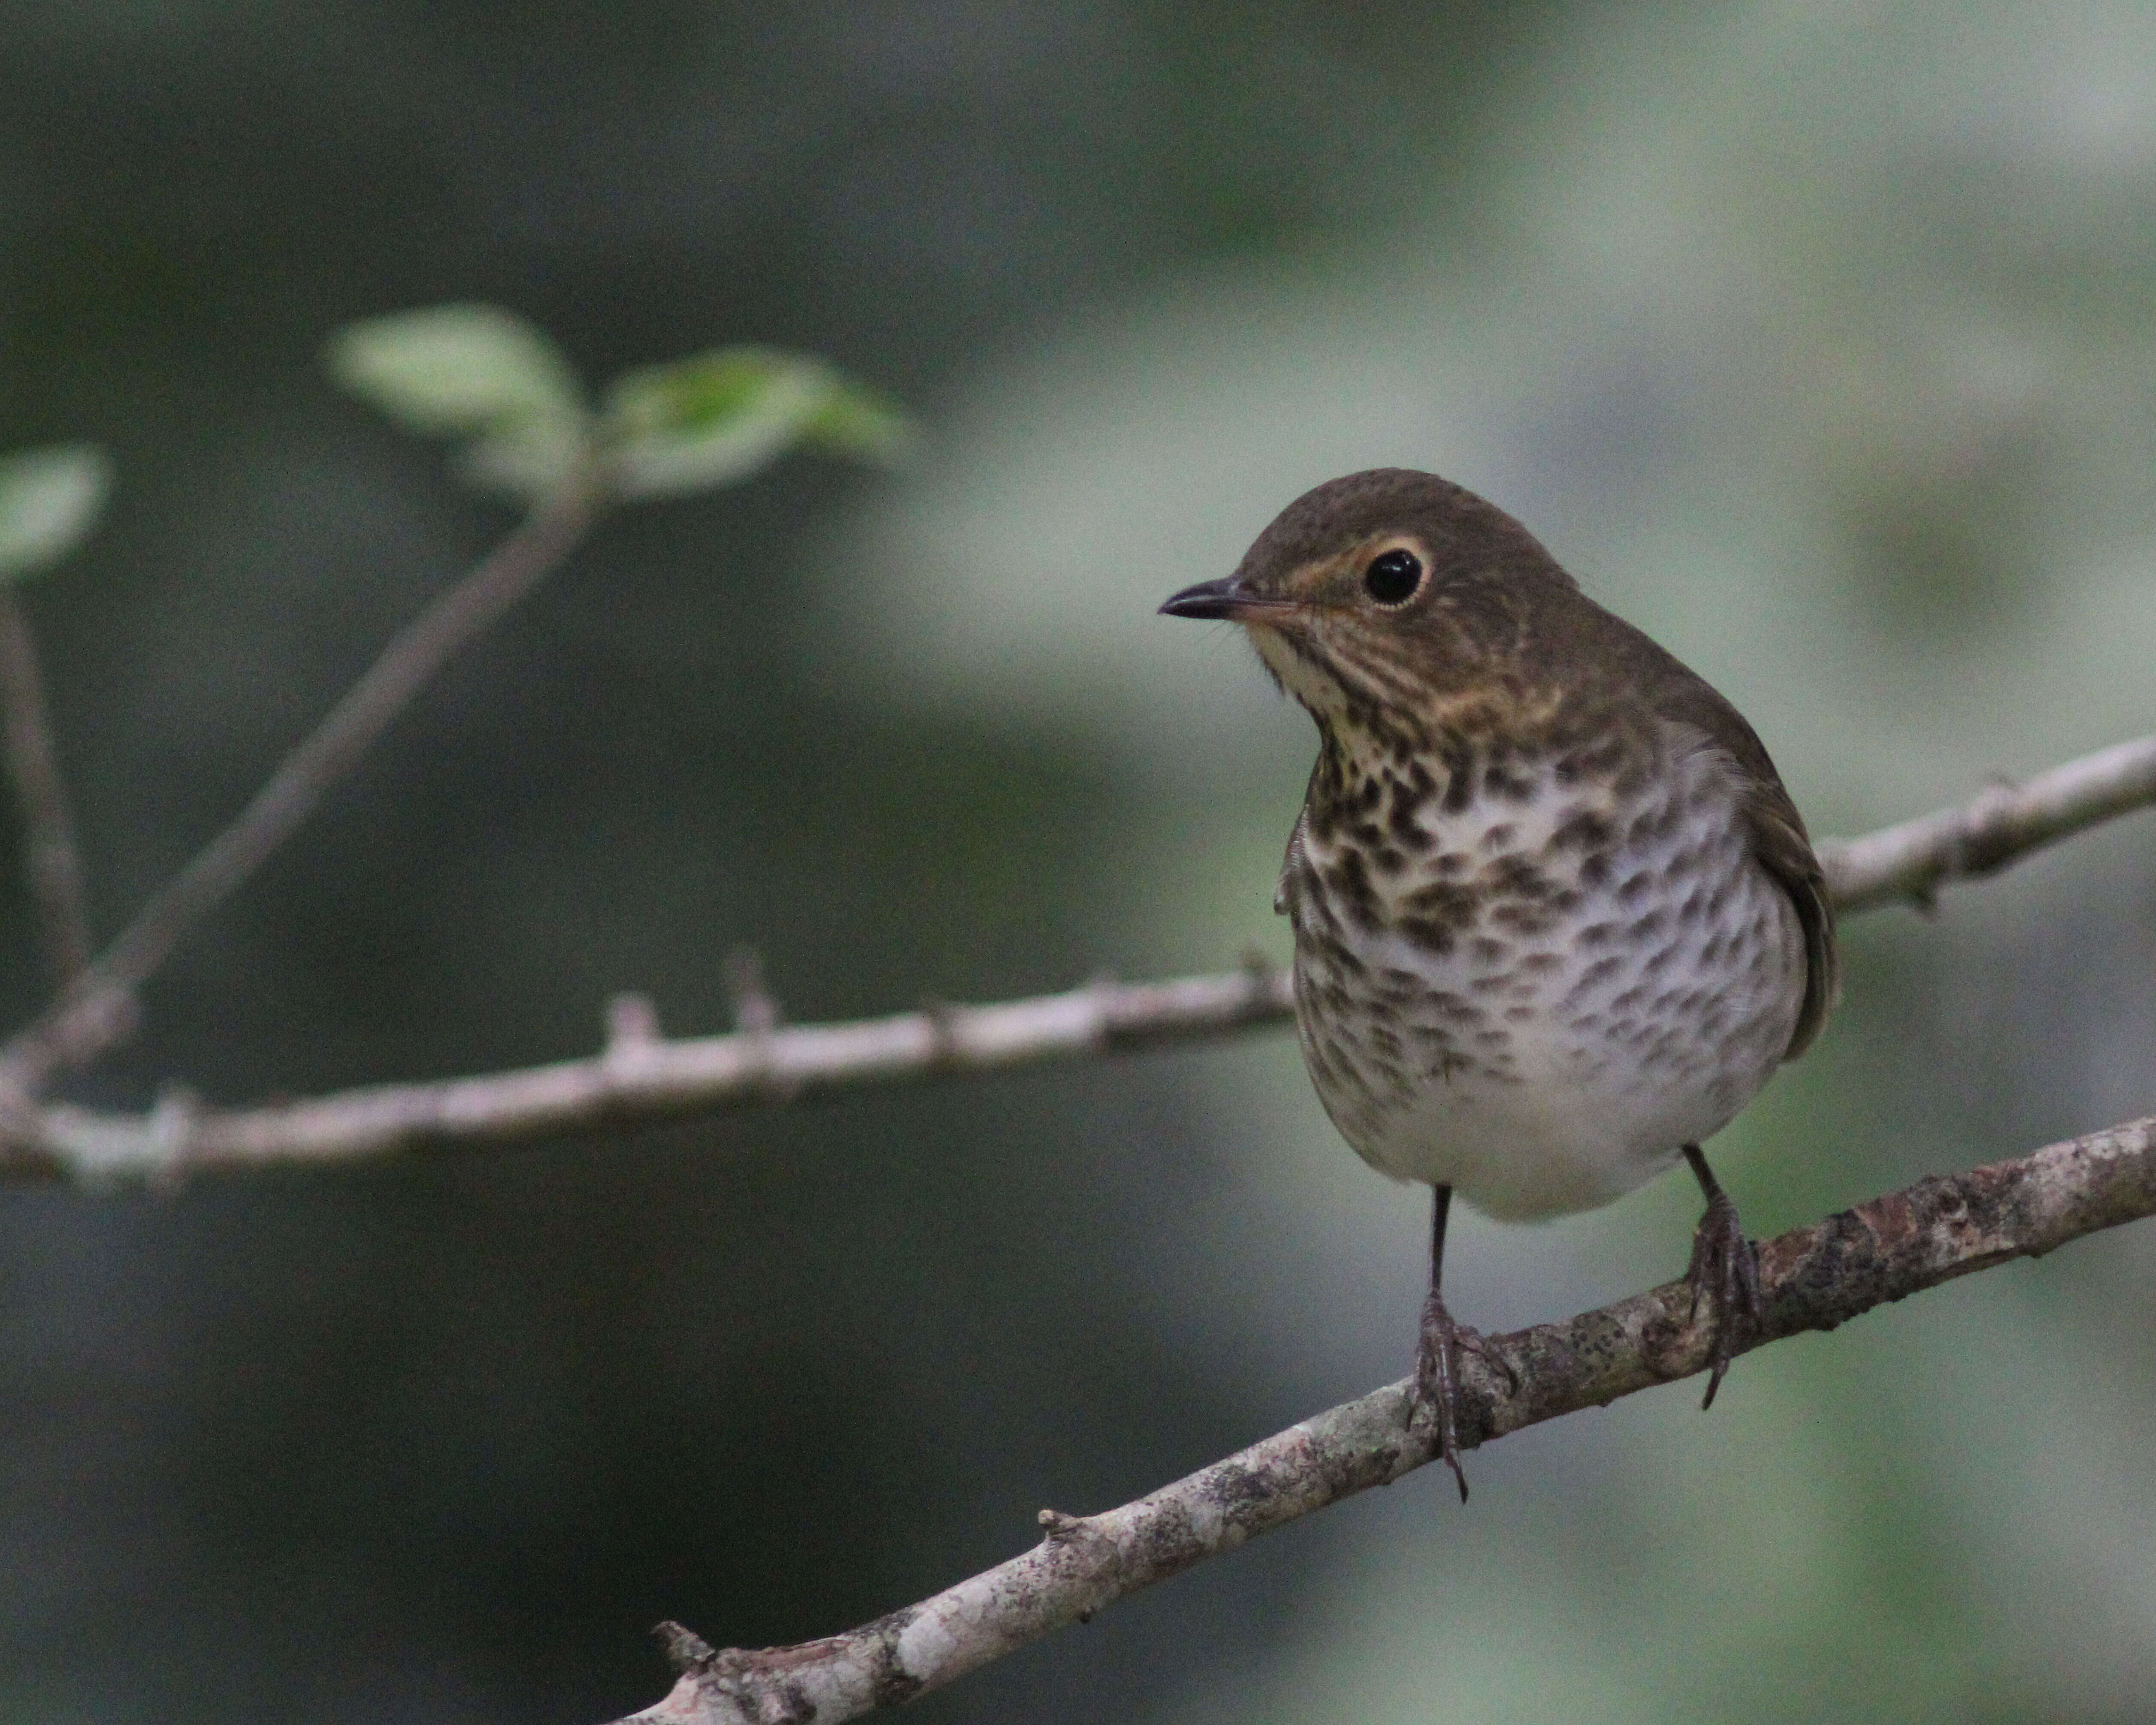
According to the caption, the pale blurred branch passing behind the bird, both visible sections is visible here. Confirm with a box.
[0,738,2156,1180]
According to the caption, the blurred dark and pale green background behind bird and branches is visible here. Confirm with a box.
[0,0,2156,1725]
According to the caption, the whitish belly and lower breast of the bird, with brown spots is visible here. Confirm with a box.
[1289,751,1805,1220]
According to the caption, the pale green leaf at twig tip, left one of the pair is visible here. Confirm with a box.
[328,306,591,498]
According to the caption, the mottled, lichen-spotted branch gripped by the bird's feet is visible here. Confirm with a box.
[617,1119,2156,1725]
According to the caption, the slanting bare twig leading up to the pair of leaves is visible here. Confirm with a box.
[0,475,602,1098]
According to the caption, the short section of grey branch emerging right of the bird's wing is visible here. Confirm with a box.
[1820,738,2156,910]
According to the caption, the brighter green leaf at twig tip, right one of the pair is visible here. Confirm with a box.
[602,347,906,498]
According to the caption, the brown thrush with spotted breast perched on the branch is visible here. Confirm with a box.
[1162,468,1835,1498]
